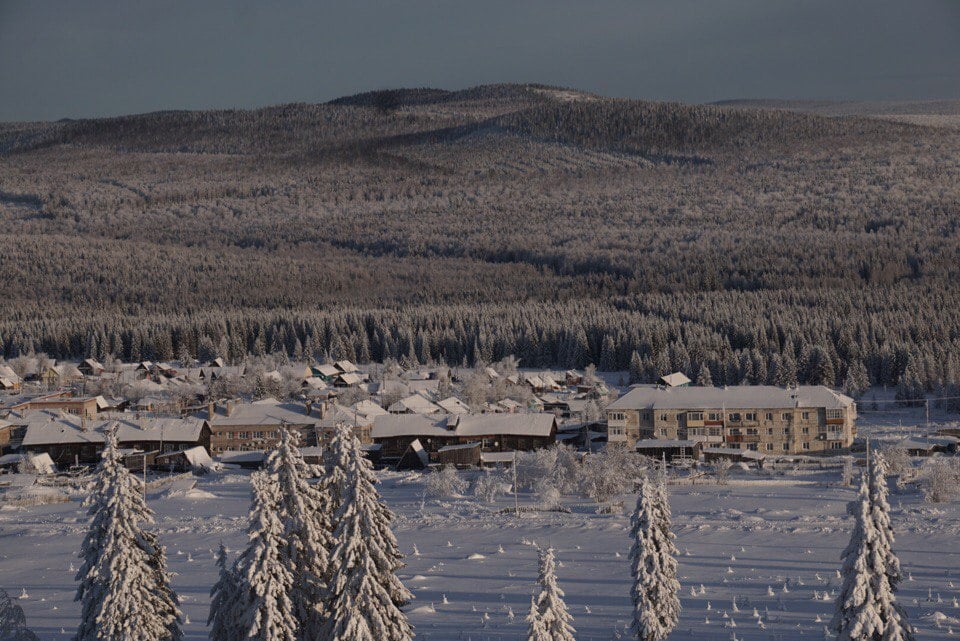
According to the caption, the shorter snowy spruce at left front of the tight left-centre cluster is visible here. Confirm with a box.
[237,472,297,641]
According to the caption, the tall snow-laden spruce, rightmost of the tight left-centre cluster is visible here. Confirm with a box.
[324,428,413,641]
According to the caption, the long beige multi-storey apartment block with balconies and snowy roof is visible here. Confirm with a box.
[606,385,857,454]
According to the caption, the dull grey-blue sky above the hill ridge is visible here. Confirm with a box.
[0,0,960,120]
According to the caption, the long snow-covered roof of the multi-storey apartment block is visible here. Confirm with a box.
[607,385,853,411]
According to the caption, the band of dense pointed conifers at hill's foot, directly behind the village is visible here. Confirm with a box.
[0,286,960,398]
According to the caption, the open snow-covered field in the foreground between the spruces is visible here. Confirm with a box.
[0,464,960,641]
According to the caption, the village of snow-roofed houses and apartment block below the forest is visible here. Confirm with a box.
[0,357,958,473]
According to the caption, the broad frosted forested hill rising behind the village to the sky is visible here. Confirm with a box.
[0,85,960,396]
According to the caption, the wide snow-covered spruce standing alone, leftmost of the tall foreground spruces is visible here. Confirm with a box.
[74,430,182,641]
